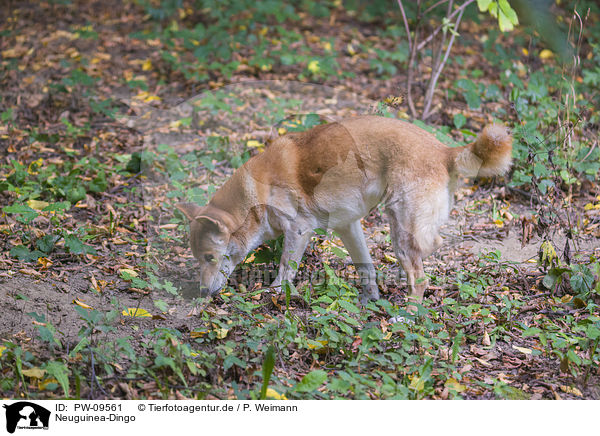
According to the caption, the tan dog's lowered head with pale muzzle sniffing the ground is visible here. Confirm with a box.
[176,203,235,297]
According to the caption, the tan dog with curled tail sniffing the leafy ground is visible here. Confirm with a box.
[177,116,512,311]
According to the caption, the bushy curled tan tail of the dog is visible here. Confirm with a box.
[451,124,512,177]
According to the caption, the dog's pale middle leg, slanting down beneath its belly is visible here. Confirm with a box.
[335,220,379,304]
